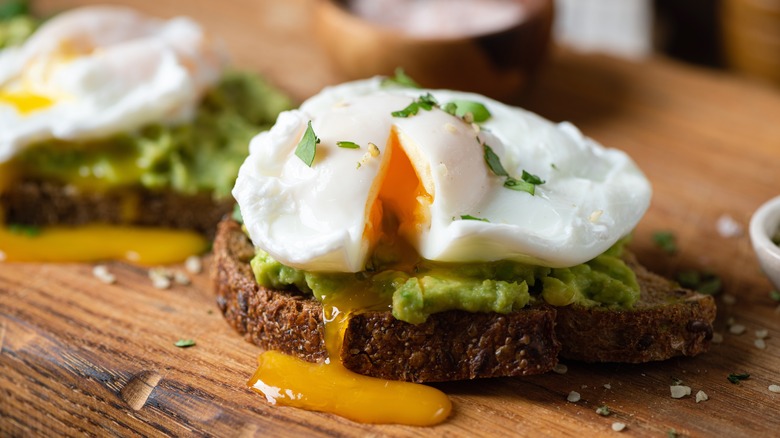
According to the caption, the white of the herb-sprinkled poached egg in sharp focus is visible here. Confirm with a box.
[233,78,651,272]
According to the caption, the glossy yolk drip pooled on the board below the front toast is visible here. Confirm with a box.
[248,284,452,426]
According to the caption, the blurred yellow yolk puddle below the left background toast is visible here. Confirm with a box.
[0,224,208,266]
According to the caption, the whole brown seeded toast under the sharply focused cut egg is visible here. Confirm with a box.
[212,219,715,383]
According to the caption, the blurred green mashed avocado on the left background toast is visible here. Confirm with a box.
[9,72,291,198]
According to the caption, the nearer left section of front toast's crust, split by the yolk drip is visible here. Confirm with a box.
[213,219,560,382]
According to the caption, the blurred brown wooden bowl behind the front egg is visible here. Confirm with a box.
[315,0,553,101]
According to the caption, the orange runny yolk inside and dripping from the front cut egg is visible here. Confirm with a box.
[248,132,452,426]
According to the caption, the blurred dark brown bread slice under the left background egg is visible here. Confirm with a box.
[0,179,234,236]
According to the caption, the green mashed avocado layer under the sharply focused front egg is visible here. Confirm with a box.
[251,241,639,324]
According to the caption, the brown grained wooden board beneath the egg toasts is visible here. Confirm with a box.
[0,0,780,437]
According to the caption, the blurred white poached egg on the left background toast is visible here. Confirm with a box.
[0,6,226,162]
